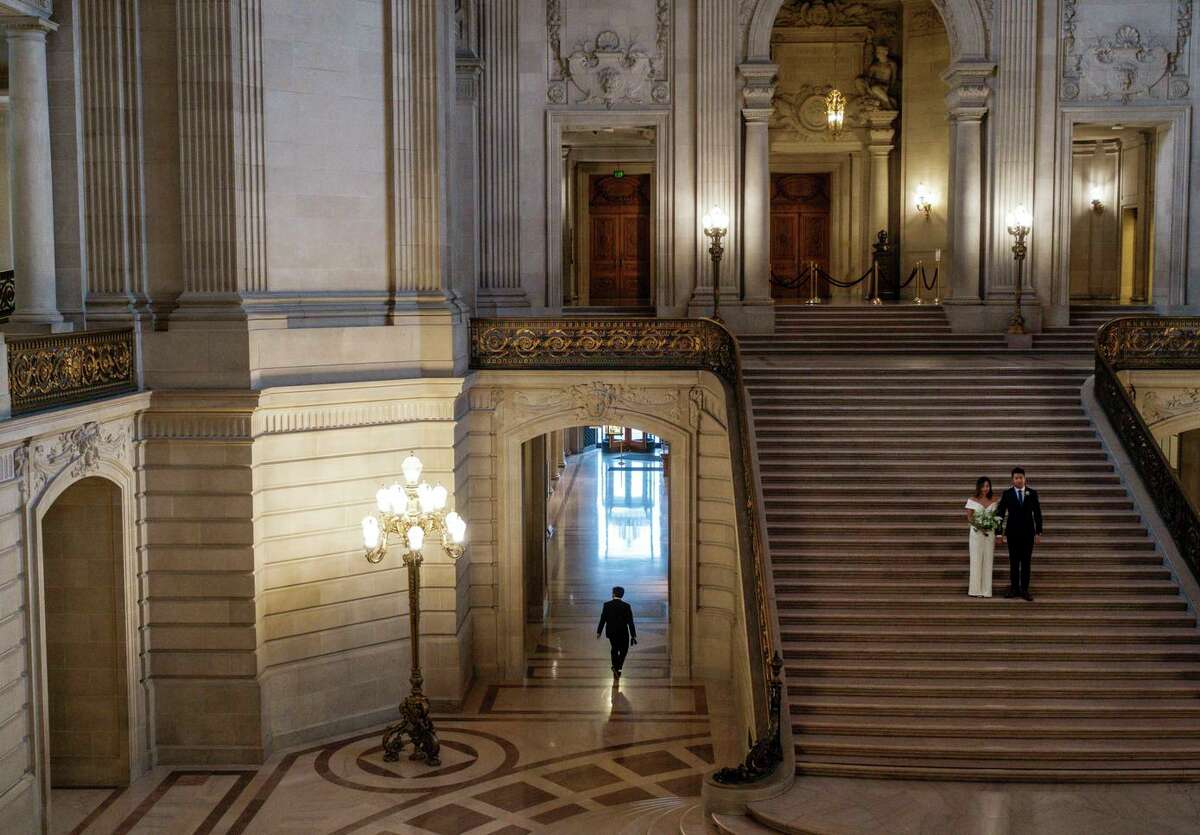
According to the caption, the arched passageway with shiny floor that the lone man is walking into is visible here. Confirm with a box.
[521,426,671,680]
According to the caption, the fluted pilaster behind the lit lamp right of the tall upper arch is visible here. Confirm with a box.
[988,0,1038,296]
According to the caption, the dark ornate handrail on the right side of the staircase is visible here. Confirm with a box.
[1096,317,1200,579]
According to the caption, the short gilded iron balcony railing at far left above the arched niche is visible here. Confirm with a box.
[6,328,138,415]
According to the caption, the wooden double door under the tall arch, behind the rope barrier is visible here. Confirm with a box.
[770,173,829,301]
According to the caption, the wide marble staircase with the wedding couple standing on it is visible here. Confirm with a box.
[743,308,1200,781]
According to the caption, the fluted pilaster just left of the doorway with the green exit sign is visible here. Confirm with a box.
[479,0,529,308]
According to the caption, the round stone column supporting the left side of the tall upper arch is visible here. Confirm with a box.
[737,64,779,334]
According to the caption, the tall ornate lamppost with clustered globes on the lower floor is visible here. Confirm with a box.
[362,453,467,765]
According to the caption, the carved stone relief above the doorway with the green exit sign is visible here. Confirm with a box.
[546,0,671,109]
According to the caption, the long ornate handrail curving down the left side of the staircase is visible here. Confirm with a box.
[470,319,784,785]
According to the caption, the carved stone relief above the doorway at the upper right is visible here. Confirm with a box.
[1062,0,1192,104]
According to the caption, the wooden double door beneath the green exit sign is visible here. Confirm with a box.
[588,174,650,307]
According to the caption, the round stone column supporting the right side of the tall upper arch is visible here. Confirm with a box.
[942,62,995,305]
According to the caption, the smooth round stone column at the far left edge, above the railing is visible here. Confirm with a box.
[0,17,71,331]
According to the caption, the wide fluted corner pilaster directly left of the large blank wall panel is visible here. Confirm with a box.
[175,0,268,317]
